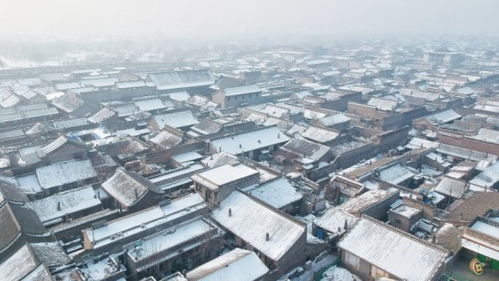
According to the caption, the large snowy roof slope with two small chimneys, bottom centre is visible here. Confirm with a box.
[212,191,306,261]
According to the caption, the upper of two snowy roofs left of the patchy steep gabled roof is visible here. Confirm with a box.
[36,160,97,189]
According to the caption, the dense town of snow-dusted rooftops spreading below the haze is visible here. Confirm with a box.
[0,42,499,281]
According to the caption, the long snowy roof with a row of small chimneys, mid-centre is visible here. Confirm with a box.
[211,126,289,155]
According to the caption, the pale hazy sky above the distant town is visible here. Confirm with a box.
[0,0,499,39]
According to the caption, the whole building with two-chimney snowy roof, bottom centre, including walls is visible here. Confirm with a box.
[212,191,307,274]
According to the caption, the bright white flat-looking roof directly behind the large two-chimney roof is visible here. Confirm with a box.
[192,164,258,190]
